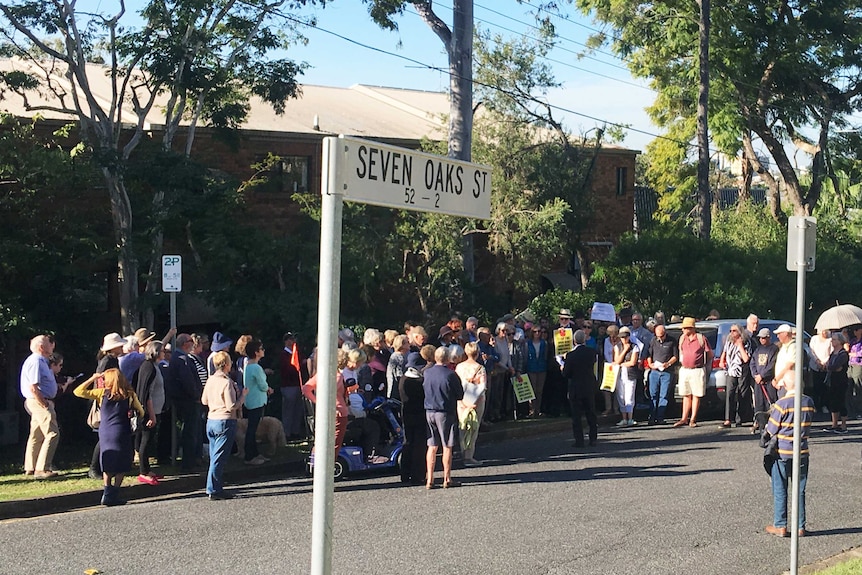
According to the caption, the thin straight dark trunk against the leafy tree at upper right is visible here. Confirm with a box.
[695,0,712,240]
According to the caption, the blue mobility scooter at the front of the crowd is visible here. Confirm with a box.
[307,397,404,481]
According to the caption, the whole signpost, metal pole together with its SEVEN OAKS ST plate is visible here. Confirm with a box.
[311,136,491,575]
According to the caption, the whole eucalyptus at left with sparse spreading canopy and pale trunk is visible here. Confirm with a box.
[0,0,322,333]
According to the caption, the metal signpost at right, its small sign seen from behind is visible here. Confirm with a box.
[787,216,817,575]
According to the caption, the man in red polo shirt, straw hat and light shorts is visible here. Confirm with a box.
[673,317,713,427]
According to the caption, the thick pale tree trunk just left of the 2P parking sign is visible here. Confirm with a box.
[102,168,139,334]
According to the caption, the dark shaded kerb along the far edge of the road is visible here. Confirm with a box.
[0,416,580,521]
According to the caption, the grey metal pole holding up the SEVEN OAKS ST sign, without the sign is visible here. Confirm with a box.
[311,137,344,575]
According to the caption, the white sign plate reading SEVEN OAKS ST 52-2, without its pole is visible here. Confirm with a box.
[336,136,491,220]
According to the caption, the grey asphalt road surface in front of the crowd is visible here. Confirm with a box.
[0,422,862,575]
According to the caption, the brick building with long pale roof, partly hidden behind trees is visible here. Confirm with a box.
[0,58,637,443]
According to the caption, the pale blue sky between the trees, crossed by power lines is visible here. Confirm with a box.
[290,0,658,150]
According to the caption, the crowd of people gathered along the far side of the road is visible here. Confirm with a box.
[21,308,862,505]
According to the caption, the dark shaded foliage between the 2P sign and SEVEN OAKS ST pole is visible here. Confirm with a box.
[126,142,326,346]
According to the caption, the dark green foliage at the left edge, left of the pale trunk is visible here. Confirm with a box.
[0,115,113,342]
